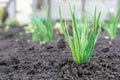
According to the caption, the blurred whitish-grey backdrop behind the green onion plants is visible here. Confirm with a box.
[0,0,120,24]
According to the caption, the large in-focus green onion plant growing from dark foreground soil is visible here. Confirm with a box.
[59,7,101,64]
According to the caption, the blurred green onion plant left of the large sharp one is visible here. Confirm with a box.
[32,9,52,42]
